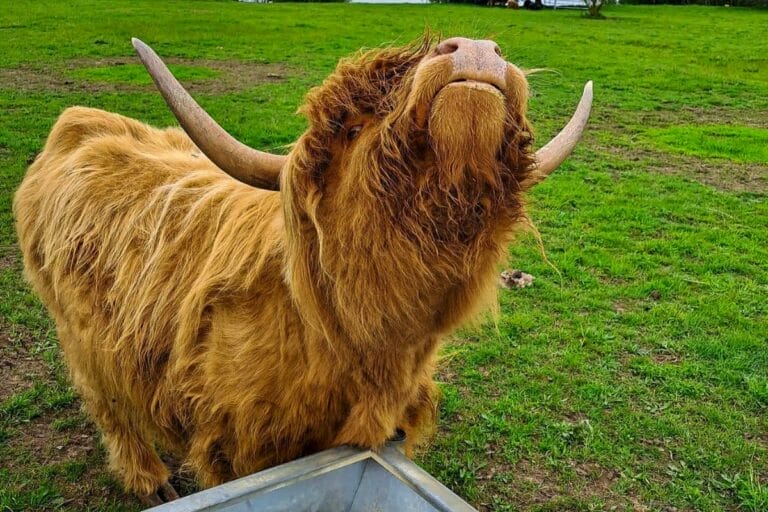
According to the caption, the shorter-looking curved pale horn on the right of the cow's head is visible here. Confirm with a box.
[521,80,592,190]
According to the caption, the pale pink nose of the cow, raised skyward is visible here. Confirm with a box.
[435,37,508,90]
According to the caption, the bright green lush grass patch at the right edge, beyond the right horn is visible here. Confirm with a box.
[647,125,768,164]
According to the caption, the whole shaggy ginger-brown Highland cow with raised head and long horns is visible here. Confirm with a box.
[14,38,591,503]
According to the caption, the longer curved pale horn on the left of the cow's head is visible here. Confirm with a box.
[131,37,287,190]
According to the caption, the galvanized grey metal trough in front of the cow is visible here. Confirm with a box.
[150,444,477,512]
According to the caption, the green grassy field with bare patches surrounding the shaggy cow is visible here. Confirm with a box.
[0,0,768,512]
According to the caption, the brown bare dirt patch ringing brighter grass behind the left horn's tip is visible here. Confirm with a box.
[0,57,297,94]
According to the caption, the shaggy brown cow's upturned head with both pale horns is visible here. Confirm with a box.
[134,38,592,244]
